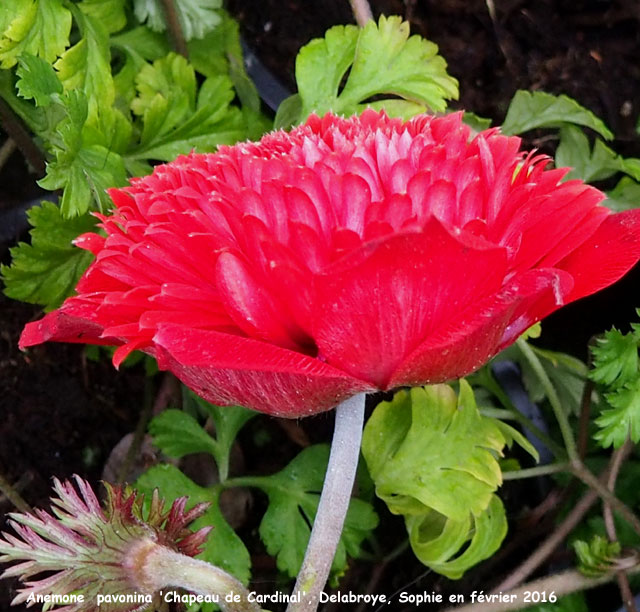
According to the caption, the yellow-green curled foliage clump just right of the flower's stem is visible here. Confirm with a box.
[362,381,507,578]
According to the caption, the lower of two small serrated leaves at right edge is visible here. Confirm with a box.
[593,377,640,448]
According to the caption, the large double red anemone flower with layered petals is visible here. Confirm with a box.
[21,110,640,417]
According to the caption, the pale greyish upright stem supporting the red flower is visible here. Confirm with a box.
[287,393,366,612]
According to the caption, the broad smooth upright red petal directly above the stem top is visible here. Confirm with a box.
[313,217,506,388]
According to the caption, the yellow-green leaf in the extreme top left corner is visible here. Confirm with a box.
[0,0,71,68]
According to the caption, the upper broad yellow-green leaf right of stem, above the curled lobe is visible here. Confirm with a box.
[362,380,505,521]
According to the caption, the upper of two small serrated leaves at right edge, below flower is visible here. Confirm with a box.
[589,328,640,389]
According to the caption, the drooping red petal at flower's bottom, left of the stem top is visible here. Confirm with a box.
[153,325,373,418]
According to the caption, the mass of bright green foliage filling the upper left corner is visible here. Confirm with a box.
[0,0,269,310]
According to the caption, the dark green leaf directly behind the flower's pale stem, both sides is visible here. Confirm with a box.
[253,445,378,578]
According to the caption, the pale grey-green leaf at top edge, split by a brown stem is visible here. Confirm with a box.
[133,0,222,40]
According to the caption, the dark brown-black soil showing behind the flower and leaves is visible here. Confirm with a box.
[0,0,640,612]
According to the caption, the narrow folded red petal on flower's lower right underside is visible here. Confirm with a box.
[388,270,571,389]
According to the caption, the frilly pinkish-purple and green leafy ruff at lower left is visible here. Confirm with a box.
[0,476,212,612]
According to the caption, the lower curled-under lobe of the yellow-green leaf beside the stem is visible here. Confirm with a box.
[405,495,507,580]
